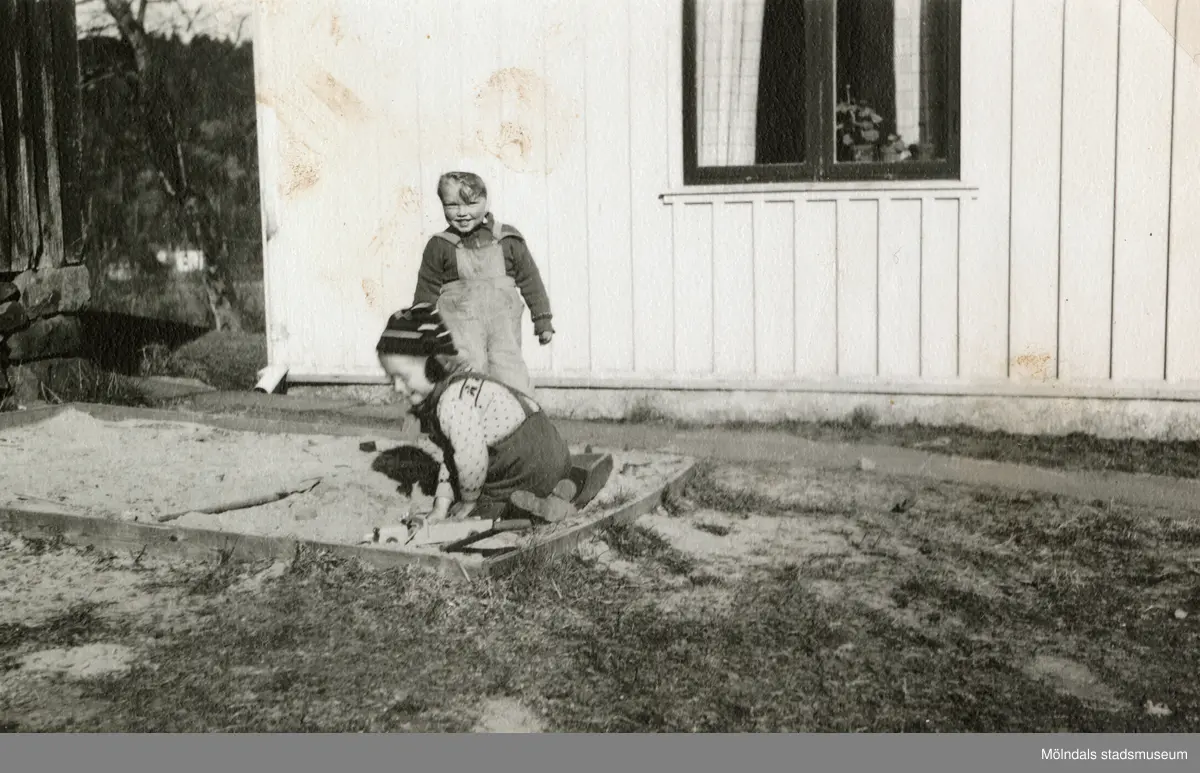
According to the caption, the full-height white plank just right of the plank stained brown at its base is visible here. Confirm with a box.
[1058,0,1118,379]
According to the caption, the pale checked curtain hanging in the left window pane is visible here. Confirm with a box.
[696,0,766,167]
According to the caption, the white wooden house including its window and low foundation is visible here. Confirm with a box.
[254,0,1200,435]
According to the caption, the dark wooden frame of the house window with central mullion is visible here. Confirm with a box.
[683,0,962,185]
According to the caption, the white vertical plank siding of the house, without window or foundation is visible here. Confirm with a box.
[258,0,1200,384]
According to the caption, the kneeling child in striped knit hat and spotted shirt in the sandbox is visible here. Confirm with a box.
[376,304,575,521]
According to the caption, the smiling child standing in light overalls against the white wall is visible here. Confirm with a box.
[413,172,554,397]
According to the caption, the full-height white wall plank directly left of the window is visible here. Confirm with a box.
[629,1,678,372]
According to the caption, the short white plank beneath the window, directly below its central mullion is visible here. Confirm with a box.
[794,200,839,378]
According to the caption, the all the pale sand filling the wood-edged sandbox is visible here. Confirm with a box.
[0,409,689,553]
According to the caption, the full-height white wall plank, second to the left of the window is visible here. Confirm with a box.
[582,0,641,372]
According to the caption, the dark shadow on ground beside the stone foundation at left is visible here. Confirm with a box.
[79,311,208,376]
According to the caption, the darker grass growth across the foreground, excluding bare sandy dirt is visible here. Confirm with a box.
[0,456,1200,732]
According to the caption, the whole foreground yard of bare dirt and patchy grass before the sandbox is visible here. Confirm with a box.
[0,453,1200,732]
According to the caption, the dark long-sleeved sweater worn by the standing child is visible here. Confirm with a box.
[413,215,553,335]
